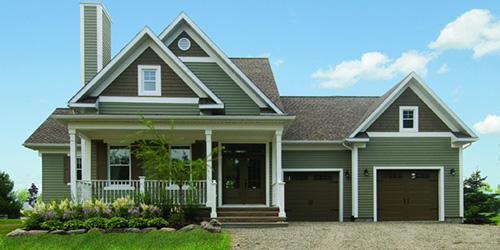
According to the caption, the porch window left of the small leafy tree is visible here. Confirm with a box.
[108,146,131,180]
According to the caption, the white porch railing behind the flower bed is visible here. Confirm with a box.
[76,178,207,205]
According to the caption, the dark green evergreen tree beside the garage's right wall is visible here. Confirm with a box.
[464,170,498,224]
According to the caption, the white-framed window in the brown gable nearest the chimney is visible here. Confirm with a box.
[138,65,161,96]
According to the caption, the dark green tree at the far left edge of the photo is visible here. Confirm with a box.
[0,172,22,218]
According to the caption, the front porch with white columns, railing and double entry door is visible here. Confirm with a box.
[63,115,286,218]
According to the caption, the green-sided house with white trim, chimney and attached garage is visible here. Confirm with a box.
[24,2,478,225]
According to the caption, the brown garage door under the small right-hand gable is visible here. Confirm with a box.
[377,170,438,221]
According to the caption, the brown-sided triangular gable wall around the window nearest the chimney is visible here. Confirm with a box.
[101,48,198,97]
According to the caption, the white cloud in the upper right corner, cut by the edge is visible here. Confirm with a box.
[429,9,500,58]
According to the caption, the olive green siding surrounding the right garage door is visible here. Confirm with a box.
[358,137,460,218]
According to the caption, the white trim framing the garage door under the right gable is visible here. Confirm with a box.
[373,166,444,221]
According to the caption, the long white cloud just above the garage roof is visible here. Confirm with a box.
[312,50,436,88]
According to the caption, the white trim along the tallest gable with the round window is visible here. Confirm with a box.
[159,12,283,114]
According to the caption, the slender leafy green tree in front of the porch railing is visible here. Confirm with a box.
[131,116,218,219]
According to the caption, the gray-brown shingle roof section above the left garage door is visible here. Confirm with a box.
[281,96,380,140]
